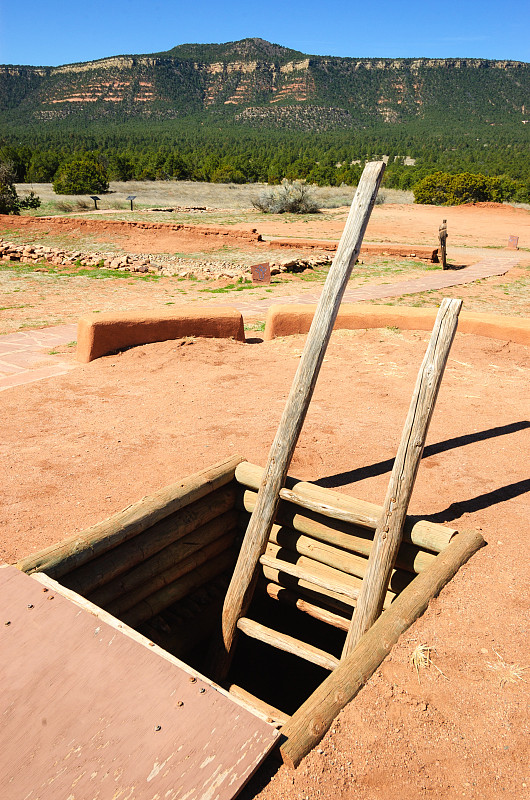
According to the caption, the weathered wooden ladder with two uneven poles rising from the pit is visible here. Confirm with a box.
[211,162,462,684]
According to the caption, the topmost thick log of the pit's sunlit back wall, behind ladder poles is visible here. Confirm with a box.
[236,461,456,553]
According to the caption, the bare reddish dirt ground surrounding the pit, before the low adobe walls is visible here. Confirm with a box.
[0,326,530,800]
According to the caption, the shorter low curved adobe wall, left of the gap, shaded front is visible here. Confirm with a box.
[76,306,245,364]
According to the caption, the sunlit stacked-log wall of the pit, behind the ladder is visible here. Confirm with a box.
[236,462,456,630]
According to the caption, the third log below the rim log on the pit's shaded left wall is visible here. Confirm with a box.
[105,531,235,617]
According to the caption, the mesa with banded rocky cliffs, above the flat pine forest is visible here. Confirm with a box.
[0,39,530,131]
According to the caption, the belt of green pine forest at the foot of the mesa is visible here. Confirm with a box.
[0,119,530,202]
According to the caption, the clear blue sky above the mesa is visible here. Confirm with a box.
[0,0,530,66]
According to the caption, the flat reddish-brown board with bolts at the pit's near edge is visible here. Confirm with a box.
[0,567,279,800]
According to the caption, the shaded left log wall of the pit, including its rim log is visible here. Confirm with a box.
[17,458,241,636]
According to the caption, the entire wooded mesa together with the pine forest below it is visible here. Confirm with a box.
[0,39,530,193]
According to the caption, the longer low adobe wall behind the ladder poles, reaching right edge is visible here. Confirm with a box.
[263,303,530,345]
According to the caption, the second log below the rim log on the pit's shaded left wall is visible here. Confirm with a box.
[89,510,237,608]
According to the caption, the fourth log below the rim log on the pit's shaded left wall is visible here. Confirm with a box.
[122,549,236,626]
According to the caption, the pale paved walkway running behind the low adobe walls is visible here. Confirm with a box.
[0,254,519,391]
